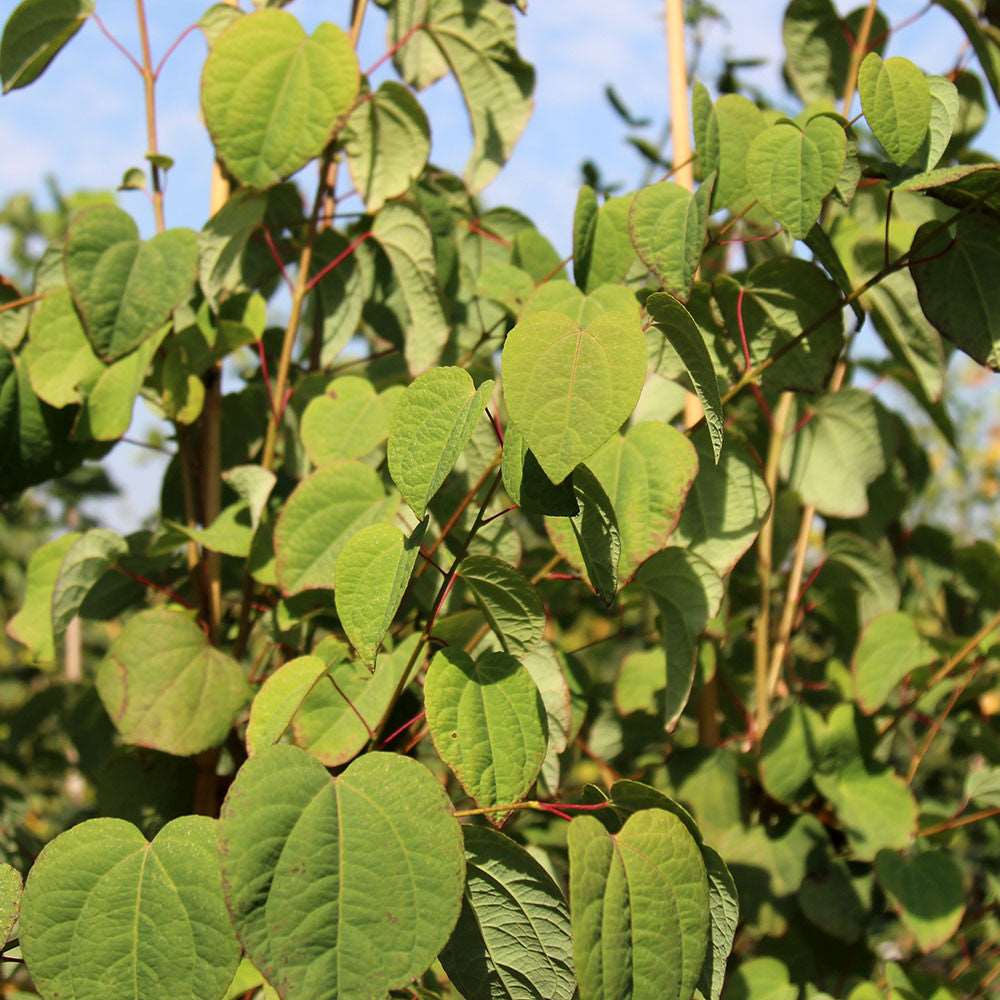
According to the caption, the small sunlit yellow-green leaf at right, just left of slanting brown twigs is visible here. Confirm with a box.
[853,611,934,715]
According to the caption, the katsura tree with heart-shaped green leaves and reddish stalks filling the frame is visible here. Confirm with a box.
[0,0,1000,1000]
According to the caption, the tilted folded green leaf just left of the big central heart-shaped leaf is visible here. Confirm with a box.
[389,368,493,517]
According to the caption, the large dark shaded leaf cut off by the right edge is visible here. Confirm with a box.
[910,215,1000,371]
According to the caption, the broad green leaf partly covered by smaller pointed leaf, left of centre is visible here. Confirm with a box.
[274,462,396,596]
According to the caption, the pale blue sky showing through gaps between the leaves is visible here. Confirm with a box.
[0,0,997,528]
